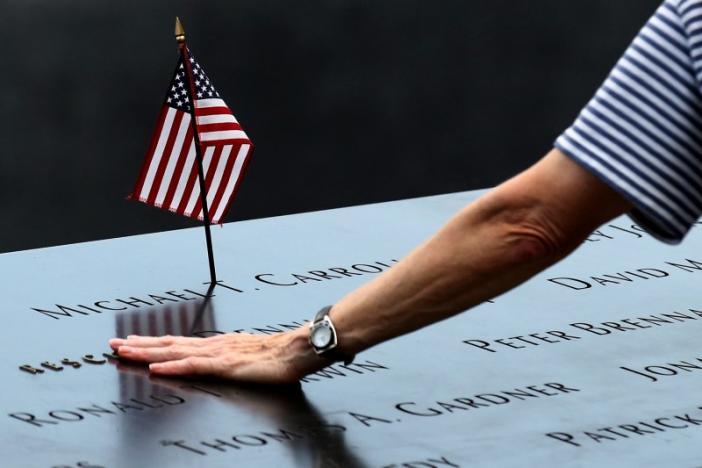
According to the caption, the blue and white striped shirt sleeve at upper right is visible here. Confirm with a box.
[555,0,702,247]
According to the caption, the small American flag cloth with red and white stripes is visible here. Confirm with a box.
[130,49,253,224]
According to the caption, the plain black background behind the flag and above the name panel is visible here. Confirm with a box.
[0,0,659,252]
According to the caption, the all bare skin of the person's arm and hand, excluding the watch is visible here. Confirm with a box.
[110,149,631,384]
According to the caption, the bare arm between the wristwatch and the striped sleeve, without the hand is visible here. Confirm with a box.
[332,150,628,352]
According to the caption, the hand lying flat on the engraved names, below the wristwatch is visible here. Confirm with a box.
[110,328,327,384]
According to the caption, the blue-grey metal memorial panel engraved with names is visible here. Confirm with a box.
[0,191,702,467]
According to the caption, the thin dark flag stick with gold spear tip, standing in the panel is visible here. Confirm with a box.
[175,16,217,286]
